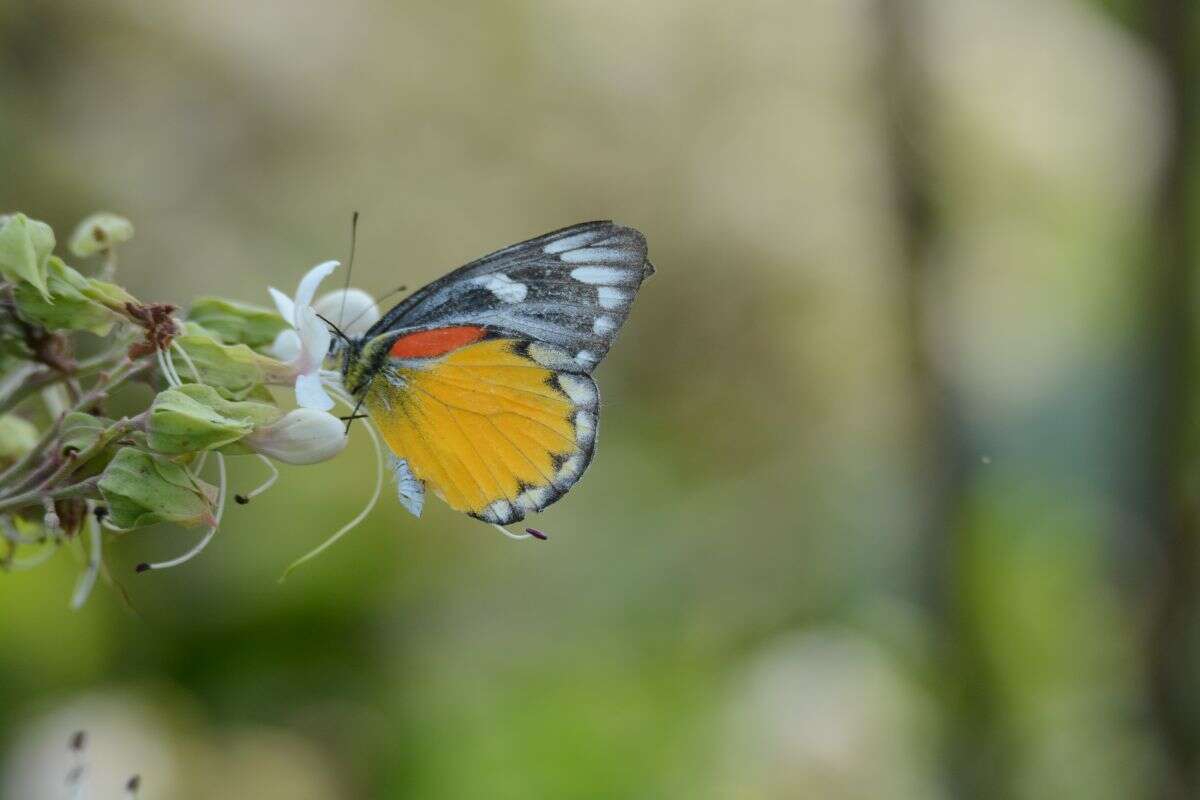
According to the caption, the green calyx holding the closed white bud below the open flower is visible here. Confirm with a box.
[146,384,283,455]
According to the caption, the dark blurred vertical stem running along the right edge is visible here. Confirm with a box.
[1138,0,1200,799]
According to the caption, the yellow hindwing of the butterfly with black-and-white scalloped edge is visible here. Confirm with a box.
[365,338,599,524]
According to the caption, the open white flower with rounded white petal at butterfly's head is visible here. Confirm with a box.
[269,261,379,411]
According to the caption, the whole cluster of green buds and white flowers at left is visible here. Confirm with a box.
[0,212,378,604]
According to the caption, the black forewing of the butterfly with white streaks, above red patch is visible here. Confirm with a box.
[366,222,654,371]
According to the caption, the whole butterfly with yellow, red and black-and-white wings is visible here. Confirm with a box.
[341,221,654,525]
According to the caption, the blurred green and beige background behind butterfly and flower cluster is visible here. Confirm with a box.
[0,0,1200,800]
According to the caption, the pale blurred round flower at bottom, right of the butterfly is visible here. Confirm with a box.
[716,630,942,800]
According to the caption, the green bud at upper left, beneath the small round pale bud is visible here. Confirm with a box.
[14,255,133,336]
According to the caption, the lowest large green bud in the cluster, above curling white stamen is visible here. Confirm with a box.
[100,447,217,528]
